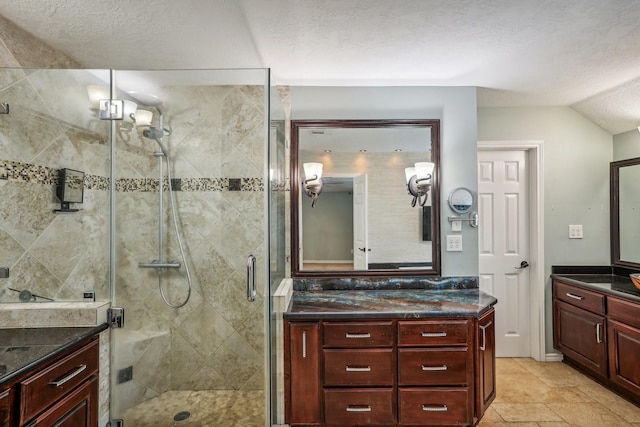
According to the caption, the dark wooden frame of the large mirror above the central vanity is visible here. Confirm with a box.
[290,119,441,278]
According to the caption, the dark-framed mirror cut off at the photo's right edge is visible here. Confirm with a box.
[609,157,640,270]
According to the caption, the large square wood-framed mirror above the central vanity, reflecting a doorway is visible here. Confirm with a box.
[291,120,440,277]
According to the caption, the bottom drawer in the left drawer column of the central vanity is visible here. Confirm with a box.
[324,388,395,426]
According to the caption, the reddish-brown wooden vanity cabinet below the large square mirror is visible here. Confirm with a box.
[285,316,495,426]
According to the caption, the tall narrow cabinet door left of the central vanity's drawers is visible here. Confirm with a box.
[285,322,322,424]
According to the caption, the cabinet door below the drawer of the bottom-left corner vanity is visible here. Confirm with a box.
[28,376,98,427]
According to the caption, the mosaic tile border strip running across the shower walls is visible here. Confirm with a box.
[0,160,264,193]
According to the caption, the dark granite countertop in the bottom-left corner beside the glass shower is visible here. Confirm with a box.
[0,324,108,387]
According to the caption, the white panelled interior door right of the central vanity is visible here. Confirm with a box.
[478,151,531,357]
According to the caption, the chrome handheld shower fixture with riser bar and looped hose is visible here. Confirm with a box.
[134,106,193,308]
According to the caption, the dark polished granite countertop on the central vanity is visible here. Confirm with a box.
[283,289,498,319]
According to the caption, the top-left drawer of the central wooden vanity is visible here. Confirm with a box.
[323,321,393,348]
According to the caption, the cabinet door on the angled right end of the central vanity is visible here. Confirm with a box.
[476,308,496,419]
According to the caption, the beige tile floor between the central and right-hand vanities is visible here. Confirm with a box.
[478,358,640,427]
